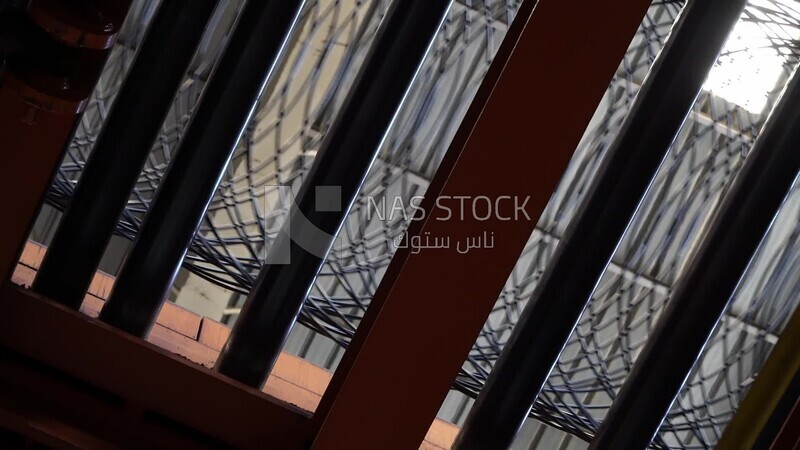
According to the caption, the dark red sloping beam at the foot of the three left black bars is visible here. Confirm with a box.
[0,285,308,450]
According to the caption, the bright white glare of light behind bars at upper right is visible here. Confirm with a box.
[703,0,800,114]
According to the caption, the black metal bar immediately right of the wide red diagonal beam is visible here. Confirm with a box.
[456,0,747,450]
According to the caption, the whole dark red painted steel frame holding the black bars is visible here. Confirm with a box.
[0,0,650,450]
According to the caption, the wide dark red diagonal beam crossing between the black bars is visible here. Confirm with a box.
[313,0,650,449]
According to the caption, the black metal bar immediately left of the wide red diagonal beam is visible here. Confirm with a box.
[216,0,450,387]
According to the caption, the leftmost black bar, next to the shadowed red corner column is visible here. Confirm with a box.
[33,0,217,309]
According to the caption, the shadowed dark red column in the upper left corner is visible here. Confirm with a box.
[0,0,130,280]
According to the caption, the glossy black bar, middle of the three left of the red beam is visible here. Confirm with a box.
[100,0,310,336]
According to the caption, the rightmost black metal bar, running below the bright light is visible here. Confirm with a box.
[590,62,800,450]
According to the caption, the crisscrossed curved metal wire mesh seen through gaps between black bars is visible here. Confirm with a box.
[31,0,800,448]
